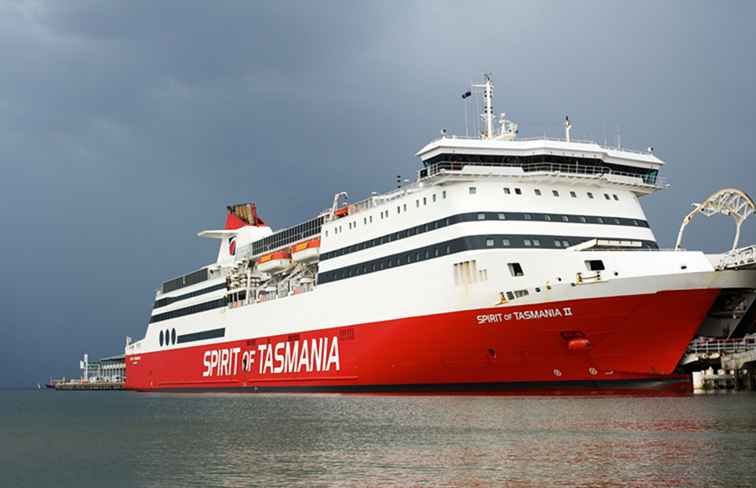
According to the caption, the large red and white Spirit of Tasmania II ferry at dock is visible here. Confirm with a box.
[125,76,756,393]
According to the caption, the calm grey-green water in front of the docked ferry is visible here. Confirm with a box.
[0,391,756,487]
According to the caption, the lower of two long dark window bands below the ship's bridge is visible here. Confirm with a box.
[318,234,658,284]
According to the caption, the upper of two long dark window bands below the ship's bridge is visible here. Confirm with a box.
[320,212,648,261]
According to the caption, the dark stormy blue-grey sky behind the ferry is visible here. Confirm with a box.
[0,0,756,386]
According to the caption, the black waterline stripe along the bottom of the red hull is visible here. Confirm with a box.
[136,375,690,394]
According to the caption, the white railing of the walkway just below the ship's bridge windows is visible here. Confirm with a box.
[425,161,666,188]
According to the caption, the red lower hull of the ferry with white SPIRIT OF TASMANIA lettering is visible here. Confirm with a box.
[125,289,719,394]
